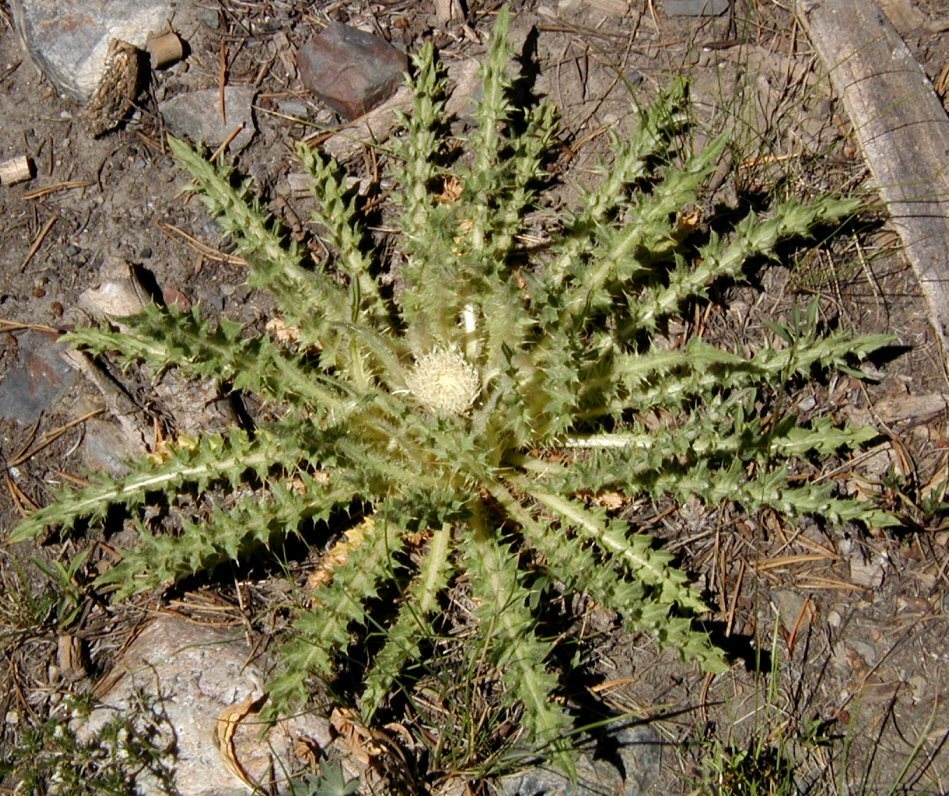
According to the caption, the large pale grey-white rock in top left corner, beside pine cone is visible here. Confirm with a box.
[13,0,173,102]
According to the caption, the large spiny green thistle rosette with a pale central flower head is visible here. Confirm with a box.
[13,10,890,766]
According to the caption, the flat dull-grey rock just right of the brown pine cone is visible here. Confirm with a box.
[158,86,257,154]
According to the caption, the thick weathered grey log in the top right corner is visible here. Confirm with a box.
[796,0,949,367]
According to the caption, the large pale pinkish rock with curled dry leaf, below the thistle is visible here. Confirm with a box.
[73,616,344,796]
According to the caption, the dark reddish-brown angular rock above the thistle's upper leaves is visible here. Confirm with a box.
[297,22,408,119]
